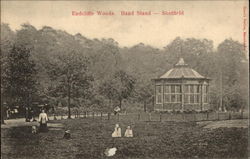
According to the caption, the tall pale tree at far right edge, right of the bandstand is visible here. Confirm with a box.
[216,39,248,110]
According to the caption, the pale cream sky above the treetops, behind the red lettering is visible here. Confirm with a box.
[1,1,248,48]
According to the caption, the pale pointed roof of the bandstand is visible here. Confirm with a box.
[158,58,207,79]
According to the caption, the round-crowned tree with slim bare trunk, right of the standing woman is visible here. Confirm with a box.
[47,52,93,118]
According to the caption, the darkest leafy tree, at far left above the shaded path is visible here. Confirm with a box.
[3,45,37,114]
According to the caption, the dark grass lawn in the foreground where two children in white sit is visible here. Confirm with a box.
[1,118,248,159]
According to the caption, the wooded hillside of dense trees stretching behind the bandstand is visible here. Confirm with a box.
[1,23,249,117]
